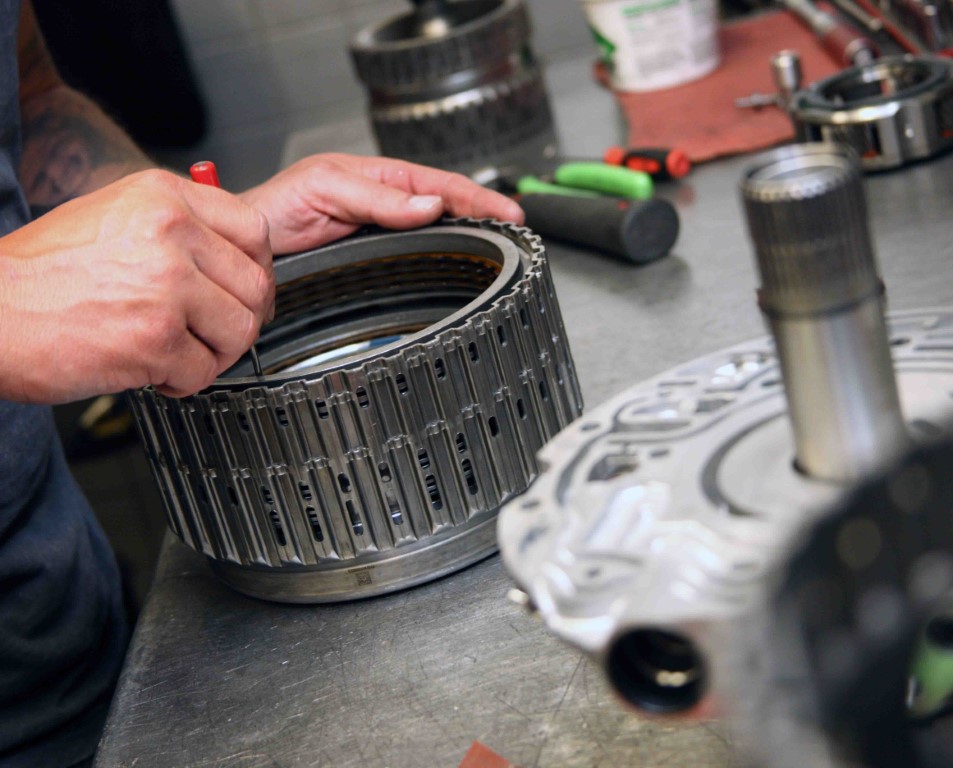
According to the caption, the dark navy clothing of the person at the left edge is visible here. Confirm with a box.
[0,0,126,768]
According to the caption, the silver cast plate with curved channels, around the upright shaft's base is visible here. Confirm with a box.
[499,310,953,740]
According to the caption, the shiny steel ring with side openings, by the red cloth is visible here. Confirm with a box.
[790,56,953,171]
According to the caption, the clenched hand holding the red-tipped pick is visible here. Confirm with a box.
[0,171,275,403]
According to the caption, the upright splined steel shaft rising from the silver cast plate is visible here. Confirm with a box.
[742,144,907,481]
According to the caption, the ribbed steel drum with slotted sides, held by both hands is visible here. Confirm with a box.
[133,219,582,602]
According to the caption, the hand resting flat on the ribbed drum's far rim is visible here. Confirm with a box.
[241,154,523,254]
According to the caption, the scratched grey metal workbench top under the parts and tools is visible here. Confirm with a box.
[96,52,953,768]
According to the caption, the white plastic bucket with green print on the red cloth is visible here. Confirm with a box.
[581,0,721,91]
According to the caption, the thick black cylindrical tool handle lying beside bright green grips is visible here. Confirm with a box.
[520,194,679,264]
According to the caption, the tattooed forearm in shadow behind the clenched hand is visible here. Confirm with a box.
[19,84,155,216]
